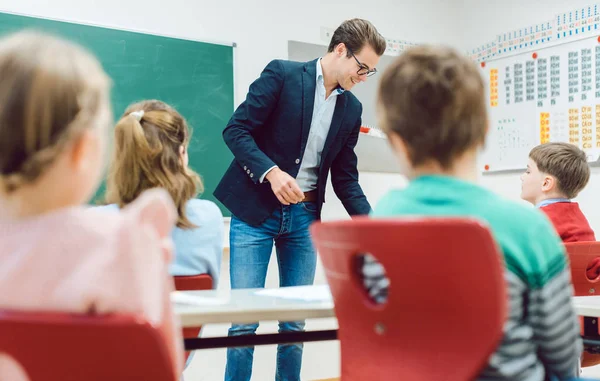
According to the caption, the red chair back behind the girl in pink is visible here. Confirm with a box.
[0,311,179,381]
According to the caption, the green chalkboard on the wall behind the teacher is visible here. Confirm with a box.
[0,13,234,216]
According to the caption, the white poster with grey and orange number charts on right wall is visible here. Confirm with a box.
[481,36,600,172]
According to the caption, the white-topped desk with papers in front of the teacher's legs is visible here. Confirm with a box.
[171,286,337,350]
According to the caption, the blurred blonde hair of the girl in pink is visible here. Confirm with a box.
[0,31,110,194]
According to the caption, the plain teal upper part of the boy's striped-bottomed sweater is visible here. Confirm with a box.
[373,176,567,288]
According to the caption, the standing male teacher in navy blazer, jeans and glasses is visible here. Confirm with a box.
[214,19,386,381]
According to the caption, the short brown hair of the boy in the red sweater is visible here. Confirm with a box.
[529,142,590,198]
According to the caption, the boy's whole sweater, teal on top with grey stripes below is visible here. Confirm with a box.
[363,176,582,381]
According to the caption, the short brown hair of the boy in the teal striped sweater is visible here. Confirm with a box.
[378,45,487,169]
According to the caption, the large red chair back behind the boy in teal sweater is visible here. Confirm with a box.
[311,218,507,381]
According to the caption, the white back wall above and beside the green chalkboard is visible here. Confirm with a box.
[0,0,460,224]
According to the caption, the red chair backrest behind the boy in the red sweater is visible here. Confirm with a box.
[565,242,600,296]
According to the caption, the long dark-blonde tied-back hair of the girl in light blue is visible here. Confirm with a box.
[106,100,203,229]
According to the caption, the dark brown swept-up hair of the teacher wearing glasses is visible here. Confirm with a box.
[327,19,387,57]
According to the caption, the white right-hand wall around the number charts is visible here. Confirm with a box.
[461,0,600,234]
